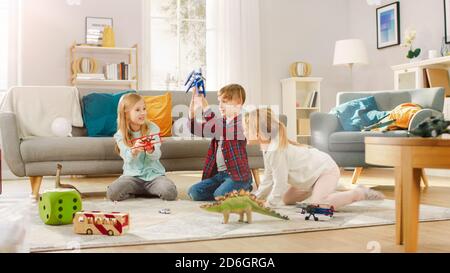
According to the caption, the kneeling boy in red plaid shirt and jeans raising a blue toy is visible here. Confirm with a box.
[188,84,252,201]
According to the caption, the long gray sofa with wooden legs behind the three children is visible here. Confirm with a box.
[0,90,285,196]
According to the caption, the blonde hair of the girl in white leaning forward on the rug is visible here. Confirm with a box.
[244,108,305,149]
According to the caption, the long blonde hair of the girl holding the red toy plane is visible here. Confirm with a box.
[115,93,148,153]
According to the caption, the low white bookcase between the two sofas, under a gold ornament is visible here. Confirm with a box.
[281,77,322,144]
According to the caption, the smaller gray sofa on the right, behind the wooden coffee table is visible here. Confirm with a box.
[311,88,445,171]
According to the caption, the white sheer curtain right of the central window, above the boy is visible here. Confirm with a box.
[206,0,261,104]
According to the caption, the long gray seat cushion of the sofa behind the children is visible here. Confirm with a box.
[20,137,262,164]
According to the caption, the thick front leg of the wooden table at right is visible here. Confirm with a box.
[402,166,422,252]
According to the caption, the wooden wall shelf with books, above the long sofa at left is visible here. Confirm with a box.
[70,43,139,89]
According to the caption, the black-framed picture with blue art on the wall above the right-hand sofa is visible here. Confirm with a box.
[377,2,400,49]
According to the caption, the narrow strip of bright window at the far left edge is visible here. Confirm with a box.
[0,0,10,92]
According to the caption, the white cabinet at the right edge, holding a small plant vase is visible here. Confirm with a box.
[391,56,450,119]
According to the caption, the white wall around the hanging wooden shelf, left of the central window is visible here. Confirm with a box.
[21,0,142,85]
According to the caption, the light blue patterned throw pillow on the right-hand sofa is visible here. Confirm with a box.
[331,96,389,131]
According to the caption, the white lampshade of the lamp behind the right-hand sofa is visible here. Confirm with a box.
[333,39,369,65]
